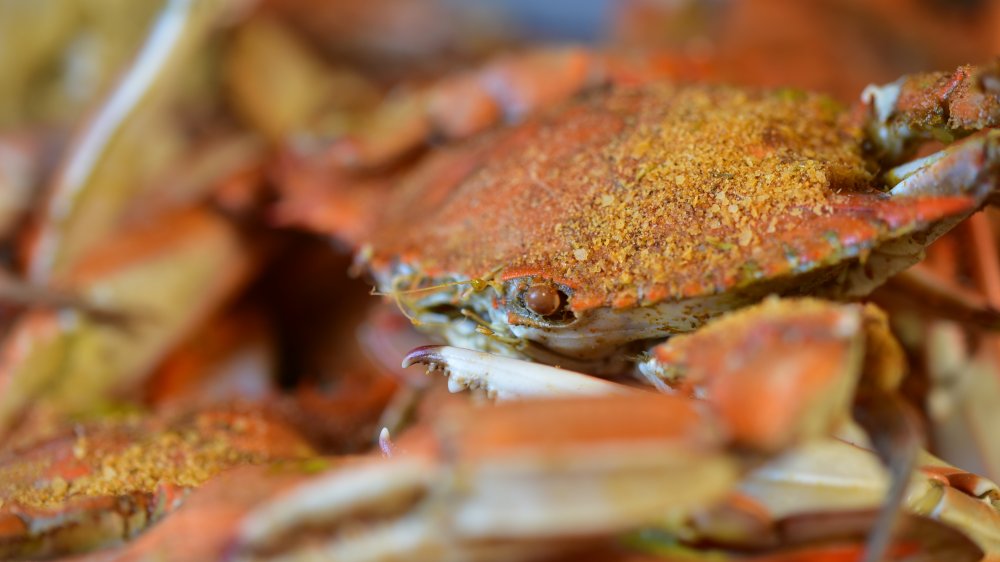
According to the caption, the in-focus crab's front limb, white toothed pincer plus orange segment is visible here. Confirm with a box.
[403,299,903,451]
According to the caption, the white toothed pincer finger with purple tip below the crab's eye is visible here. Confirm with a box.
[403,345,634,400]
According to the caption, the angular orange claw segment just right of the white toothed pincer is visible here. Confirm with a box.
[640,299,884,450]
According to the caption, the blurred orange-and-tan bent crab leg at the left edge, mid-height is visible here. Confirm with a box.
[0,208,260,434]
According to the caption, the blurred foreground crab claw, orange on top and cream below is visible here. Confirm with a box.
[234,393,737,561]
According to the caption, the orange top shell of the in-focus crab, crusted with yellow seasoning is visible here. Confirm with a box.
[366,83,978,312]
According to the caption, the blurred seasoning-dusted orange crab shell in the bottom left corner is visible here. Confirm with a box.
[0,406,312,560]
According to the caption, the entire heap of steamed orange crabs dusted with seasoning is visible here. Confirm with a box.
[0,0,1000,562]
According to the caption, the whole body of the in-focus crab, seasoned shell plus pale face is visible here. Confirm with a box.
[360,77,1000,369]
